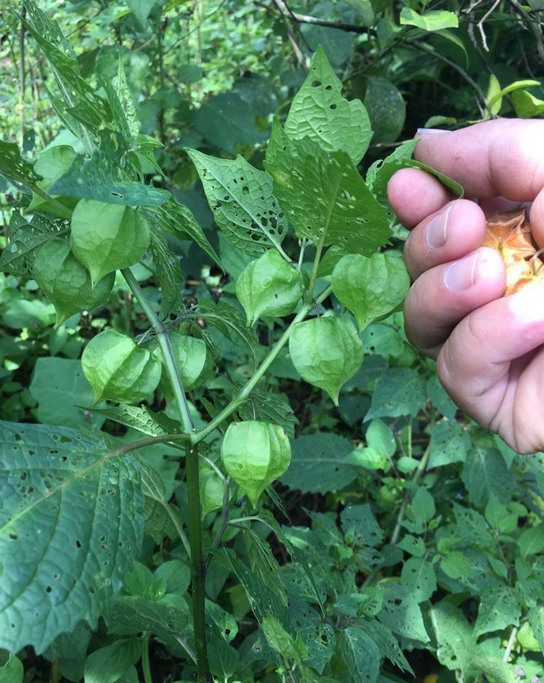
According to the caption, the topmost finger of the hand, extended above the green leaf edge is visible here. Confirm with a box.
[415,119,544,202]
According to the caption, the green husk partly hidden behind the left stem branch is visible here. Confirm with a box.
[161,332,213,401]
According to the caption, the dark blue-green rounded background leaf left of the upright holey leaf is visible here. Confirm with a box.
[193,92,266,154]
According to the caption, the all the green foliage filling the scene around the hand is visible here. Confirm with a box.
[0,0,544,683]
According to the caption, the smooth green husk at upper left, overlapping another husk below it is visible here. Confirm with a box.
[71,199,150,285]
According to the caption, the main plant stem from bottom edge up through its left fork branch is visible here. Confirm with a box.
[122,268,213,683]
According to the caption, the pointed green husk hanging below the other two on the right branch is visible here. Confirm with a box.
[289,317,364,405]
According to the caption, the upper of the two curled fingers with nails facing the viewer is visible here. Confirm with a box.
[404,199,486,278]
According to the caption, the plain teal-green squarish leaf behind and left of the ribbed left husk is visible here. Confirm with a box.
[29,358,105,430]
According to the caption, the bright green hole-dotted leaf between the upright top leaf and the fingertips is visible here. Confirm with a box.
[265,121,391,256]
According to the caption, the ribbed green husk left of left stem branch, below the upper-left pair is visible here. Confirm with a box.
[81,330,161,403]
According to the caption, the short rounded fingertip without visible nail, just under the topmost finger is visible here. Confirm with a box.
[387,168,452,228]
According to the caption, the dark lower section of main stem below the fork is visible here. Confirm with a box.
[185,444,213,683]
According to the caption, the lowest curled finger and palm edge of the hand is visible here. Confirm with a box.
[437,283,544,452]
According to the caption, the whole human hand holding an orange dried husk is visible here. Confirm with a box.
[388,119,544,453]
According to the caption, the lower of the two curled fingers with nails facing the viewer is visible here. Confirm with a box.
[404,247,506,358]
